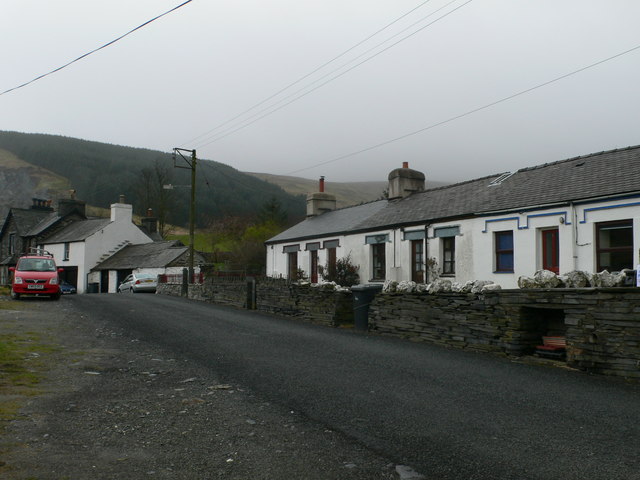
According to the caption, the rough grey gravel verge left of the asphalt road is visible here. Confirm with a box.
[0,298,400,480]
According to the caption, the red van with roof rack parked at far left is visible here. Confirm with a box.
[9,250,63,300]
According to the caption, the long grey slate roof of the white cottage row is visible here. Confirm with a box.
[267,146,640,243]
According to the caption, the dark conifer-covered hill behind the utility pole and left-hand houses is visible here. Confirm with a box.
[0,131,305,227]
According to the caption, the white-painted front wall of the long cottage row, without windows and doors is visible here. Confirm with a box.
[267,199,640,288]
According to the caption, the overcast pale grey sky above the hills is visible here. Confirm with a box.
[0,0,640,184]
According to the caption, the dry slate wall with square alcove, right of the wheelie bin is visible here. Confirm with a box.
[369,288,640,378]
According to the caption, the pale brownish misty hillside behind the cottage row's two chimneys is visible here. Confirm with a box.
[249,172,446,208]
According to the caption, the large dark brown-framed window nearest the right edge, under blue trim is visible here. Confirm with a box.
[596,220,633,272]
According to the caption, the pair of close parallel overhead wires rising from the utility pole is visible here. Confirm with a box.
[191,0,473,148]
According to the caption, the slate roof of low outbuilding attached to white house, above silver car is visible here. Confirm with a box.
[93,240,189,270]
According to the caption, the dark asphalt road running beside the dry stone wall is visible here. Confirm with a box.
[70,294,640,480]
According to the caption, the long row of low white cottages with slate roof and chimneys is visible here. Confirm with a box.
[266,146,640,288]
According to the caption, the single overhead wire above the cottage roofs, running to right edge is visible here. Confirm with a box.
[285,45,640,175]
